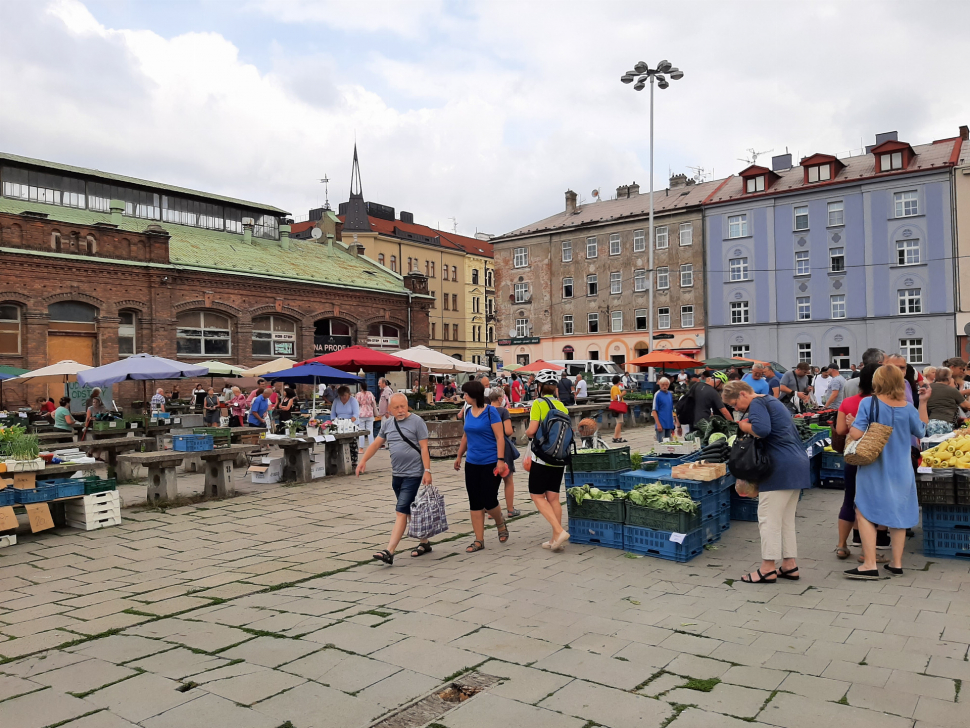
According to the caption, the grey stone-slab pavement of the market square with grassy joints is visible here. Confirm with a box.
[0,430,970,728]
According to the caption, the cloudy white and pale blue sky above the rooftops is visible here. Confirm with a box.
[0,0,970,235]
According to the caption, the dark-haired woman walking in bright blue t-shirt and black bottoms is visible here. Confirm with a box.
[455,381,509,553]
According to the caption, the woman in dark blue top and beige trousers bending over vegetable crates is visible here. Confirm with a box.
[721,381,811,584]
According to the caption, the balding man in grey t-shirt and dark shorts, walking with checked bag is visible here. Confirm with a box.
[357,392,431,565]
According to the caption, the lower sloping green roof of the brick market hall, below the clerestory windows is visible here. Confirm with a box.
[0,197,407,294]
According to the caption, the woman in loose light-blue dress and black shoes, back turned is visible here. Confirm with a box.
[845,365,929,579]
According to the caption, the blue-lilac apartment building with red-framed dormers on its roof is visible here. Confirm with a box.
[704,130,963,368]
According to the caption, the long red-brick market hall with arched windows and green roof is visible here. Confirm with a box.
[0,154,432,406]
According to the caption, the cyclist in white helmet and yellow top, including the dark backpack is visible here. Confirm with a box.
[525,369,574,551]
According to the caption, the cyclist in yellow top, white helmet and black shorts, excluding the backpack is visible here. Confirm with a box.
[524,369,569,551]
